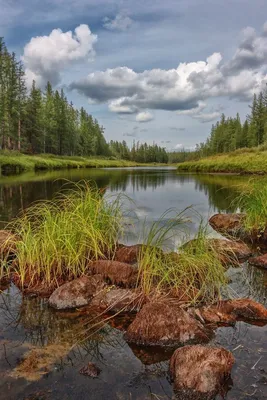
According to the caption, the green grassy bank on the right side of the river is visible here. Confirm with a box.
[177,148,267,174]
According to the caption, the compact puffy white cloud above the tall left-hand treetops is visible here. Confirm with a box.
[22,25,97,86]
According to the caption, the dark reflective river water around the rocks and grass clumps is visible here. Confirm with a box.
[0,169,267,400]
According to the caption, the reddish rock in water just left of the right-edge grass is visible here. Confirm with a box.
[209,214,245,237]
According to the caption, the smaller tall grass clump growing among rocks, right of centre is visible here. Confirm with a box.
[139,213,227,304]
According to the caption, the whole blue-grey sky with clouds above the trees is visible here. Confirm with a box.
[0,0,267,150]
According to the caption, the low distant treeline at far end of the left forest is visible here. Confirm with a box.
[109,140,168,163]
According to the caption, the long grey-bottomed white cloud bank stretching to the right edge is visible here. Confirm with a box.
[70,20,267,122]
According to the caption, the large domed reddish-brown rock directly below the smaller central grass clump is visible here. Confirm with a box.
[125,301,212,346]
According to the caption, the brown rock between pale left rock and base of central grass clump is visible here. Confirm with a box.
[91,288,145,313]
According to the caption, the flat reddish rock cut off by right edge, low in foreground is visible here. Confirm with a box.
[199,299,267,323]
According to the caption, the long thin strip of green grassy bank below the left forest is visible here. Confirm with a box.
[0,152,163,173]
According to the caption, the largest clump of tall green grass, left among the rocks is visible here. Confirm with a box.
[10,182,122,285]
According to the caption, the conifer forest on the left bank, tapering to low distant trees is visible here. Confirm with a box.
[0,38,168,163]
